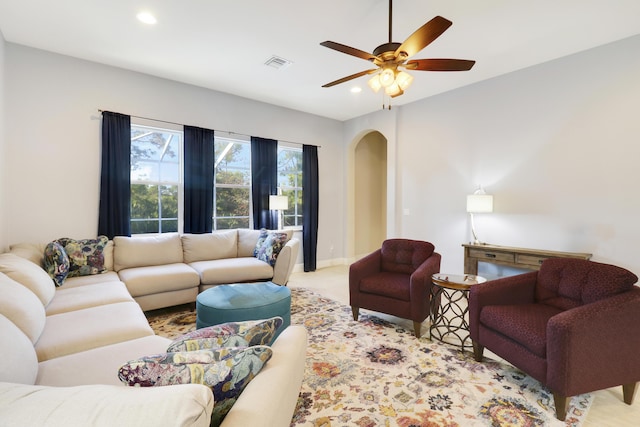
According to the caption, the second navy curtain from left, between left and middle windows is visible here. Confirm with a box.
[183,126,215,234]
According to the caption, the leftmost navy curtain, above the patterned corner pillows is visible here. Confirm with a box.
[98,111,131,239]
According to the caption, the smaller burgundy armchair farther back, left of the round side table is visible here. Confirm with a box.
[349,239,441,338]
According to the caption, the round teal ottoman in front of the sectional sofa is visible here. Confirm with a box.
[196,282,291,336]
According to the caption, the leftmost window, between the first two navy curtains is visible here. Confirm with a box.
[131,124,182,234]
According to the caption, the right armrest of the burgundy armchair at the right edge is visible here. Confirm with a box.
[547,287,640,396]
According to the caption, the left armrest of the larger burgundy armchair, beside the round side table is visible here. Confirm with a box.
[469,271,538,341]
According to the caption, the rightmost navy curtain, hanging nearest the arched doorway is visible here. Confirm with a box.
[302,145,319,271]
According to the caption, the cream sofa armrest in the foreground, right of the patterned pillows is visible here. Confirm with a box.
[221,325,307,427]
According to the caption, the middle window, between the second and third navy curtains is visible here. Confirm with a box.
[213,136,251,230]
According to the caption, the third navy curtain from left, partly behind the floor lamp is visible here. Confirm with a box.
[251,136,278,230]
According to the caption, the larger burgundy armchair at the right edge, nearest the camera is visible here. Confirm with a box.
[469,258,640,420]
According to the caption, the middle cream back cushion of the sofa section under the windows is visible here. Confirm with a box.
[182,230,238,263]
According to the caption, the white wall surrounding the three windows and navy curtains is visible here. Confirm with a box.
[0,43,344,261]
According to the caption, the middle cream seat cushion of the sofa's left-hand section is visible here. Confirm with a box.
[35,302,153,361]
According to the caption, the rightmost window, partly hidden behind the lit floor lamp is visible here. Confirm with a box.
[278,143,302,228]
